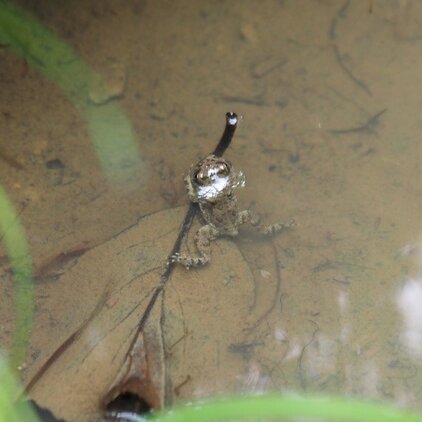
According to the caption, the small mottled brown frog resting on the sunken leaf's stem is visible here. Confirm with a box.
[170,154,294,269]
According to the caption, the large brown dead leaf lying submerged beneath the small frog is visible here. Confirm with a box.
[22,204,278,422]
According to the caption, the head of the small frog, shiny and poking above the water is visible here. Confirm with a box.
[185,155,245,202]
